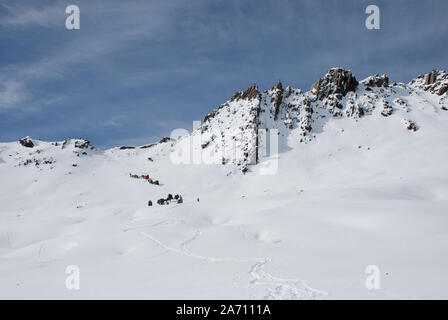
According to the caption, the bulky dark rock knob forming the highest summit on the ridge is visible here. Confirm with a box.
[310,68,358,100]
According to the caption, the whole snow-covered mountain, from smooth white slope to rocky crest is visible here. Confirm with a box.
[0,68,448,299]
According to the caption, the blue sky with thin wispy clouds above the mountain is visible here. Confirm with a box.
[0,0,448,148]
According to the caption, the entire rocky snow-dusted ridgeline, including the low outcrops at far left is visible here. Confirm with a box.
[0,68,448,172]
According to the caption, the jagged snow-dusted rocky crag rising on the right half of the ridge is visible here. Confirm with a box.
[193,68,448,171]
